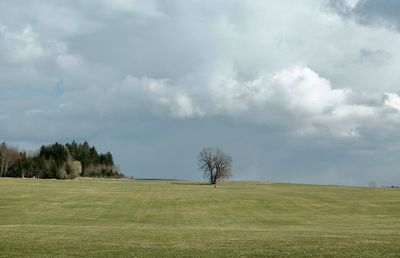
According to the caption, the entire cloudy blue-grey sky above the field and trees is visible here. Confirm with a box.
[0,0,400,185]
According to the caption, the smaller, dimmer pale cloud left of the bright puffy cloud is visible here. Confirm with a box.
[60,76,203,119]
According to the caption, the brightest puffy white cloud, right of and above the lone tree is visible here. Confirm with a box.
[206,67,377,137]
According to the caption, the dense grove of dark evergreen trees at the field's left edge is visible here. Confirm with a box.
[0,141,124,179]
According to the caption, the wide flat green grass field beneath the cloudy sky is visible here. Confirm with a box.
[0,179,400,257]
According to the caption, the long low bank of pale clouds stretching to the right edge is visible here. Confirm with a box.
[58,67,399,137]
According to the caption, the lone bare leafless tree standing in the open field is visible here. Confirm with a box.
[198,148,232,186]
